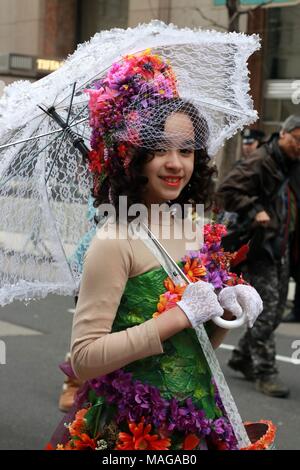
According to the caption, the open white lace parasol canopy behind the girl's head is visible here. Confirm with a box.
[0,21,259,305]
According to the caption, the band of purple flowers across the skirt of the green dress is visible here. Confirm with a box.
[89,369,237,449]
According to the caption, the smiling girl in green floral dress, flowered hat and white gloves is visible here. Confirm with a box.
[51,51,268,450]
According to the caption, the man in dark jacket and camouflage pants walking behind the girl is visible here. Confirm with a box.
[217,116,300,397]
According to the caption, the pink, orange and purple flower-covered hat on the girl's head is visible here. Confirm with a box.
[86,49,179,175]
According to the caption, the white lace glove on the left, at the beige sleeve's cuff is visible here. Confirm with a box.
[177,281,224,328]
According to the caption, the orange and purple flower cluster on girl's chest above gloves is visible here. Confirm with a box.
[153,223,248,318]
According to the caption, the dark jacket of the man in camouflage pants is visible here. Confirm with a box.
[217,134,300,261]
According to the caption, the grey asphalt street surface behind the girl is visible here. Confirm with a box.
[0,295,300,450]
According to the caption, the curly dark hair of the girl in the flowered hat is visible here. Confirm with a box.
[92,98,217,217]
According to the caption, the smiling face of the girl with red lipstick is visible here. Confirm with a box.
[143,113,194,205]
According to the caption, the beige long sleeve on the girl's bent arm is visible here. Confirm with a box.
[71,237,163,380]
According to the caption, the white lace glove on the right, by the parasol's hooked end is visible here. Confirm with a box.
[218,284,263,328]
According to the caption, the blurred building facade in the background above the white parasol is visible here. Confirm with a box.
[0,0,300,132]
